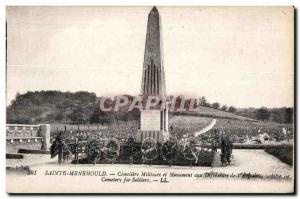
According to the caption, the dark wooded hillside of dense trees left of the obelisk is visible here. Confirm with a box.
[6,90,97,123]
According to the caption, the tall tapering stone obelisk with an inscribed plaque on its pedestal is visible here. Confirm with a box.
[137,6,169,143]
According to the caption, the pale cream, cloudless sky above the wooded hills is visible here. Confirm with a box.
[6,6,294,108]
